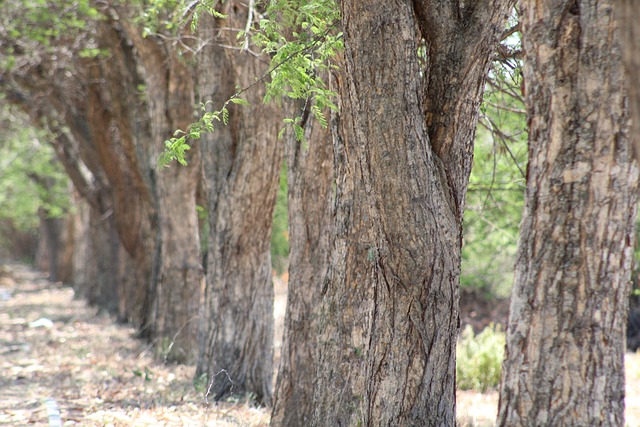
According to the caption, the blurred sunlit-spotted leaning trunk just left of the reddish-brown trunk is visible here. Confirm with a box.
[44,88,133,320]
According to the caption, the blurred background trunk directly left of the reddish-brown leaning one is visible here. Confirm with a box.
[41,123,126,314]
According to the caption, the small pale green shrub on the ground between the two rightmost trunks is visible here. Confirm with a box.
[456,324,505,393]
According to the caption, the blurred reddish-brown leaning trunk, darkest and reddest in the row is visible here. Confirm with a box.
[86,53,156,332]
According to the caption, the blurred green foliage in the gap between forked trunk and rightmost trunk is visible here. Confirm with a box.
[461,36,528,297]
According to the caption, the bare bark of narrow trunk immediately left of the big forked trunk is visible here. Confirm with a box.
[271,103,335,427]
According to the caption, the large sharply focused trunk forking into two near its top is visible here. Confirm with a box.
[313,0,509,426]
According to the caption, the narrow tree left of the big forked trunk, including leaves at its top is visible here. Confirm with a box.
[257,0,342,426]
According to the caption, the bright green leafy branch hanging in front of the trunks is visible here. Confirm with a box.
[160,0,343,166]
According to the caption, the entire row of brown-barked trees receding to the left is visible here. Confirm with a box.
[0,0,640,426]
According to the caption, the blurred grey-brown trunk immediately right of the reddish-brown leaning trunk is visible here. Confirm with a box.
[128,18,206,362]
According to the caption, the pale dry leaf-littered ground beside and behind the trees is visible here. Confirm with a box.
[0,264,640,427]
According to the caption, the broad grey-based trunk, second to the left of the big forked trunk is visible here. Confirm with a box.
[197,6,282,404]
